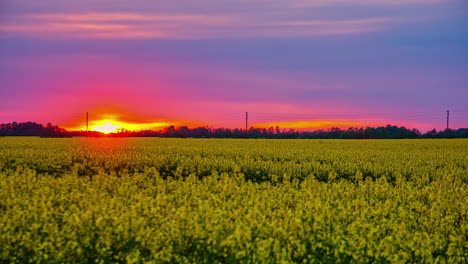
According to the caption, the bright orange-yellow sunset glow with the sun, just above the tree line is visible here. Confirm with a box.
[59,103,412,133]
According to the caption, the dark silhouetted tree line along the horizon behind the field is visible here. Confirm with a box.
[0,122,468,139]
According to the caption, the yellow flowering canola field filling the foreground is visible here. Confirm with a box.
[0,138,468,263]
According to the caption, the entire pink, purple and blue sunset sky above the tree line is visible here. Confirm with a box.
[0,0,468,132]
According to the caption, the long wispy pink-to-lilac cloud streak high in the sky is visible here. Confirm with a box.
[0,12,406,39]
